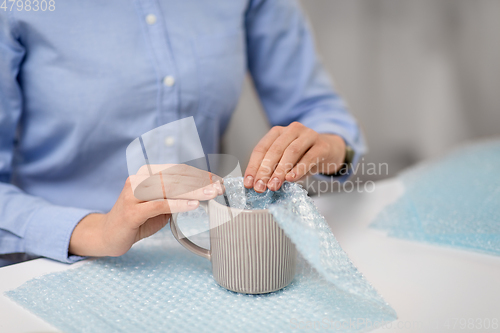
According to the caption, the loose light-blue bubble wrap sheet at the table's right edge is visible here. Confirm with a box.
[371,141,500,255]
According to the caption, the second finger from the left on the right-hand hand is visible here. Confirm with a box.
[254,128,299,192]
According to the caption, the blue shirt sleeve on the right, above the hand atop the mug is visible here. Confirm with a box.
[245,0,366,180]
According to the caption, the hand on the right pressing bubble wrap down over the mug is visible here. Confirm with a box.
[244,122,346,192]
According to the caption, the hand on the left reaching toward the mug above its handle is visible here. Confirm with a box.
[69,164,223,257]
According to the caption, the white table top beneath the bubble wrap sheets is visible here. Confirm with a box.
[0,180,500,333]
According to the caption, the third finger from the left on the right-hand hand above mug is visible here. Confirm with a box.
[267,135,315,191]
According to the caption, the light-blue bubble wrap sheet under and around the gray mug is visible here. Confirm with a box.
[6,178,396,332]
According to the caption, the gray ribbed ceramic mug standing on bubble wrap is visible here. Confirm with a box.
[170,200,297,294]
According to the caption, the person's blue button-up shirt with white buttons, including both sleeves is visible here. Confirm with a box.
[0,0,365,262]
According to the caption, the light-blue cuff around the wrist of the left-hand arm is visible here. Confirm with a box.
[24,205,96,263]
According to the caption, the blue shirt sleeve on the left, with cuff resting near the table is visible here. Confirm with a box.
[0,12,92,263]
